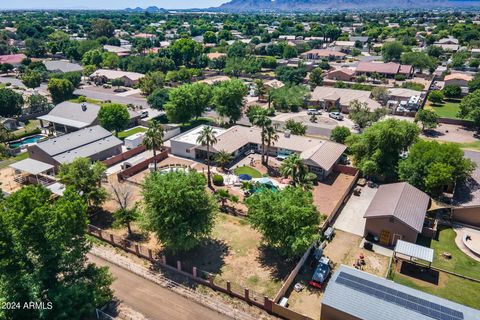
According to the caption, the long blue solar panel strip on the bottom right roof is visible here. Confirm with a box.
[336,271,463,320]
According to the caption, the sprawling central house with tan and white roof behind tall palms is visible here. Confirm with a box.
[170,125,346,179]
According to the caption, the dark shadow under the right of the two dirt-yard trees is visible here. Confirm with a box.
[257,244,296,280]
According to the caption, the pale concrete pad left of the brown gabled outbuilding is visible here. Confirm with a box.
[333,186,378,237]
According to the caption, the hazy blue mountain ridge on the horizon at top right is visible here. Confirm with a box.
[217,0,480,12]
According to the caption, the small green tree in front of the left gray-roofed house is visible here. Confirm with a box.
[58,158,107,206]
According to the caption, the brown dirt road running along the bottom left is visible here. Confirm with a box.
[87,254,230,320]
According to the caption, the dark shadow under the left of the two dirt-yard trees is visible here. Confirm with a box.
[159,238,229,274]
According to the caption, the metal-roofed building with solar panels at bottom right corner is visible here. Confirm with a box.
[320,265,479,320]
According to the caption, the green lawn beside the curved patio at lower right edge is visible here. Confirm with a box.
[417,226,480,279]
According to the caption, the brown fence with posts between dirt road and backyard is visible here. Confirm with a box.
[87,225,312,320]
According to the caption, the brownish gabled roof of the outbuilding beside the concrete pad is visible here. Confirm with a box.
[364,182,430,232]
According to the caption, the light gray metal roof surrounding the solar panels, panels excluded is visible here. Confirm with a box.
[322,265,480,320]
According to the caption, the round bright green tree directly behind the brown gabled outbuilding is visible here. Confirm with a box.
[398,140,475,197]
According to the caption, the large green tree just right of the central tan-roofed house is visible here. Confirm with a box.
[346,119,420,179]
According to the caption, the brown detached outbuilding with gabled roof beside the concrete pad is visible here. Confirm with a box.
[364,182,430,246]
